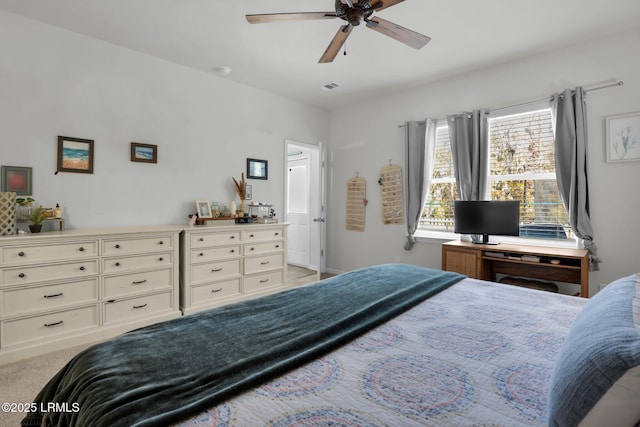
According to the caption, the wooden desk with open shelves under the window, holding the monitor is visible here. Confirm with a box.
[442,240,589,298]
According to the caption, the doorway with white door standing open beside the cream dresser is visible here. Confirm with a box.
[285,140,324,278]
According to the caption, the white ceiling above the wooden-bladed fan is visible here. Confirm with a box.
[0,0,640,108]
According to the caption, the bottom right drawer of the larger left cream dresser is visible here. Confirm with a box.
[104,292,173,325]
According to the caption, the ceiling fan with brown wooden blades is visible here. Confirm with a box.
[246,0,431,63]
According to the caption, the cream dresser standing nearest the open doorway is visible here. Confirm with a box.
[180,224,287,314]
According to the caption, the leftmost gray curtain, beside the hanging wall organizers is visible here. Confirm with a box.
[404,119,436,251]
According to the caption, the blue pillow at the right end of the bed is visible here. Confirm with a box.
[548,275,640,427]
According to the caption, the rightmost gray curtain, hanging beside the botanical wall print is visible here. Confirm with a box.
[551,87,600,271]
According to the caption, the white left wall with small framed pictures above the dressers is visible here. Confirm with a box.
[0,12,329,228]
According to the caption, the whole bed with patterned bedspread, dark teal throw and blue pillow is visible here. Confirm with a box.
[23,264,640,427]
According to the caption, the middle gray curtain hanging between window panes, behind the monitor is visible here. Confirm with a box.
[447,109,489,200]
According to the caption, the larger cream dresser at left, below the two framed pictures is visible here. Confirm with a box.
[0,226,182,363]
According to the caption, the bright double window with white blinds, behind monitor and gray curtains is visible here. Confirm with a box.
[420,108,573,239]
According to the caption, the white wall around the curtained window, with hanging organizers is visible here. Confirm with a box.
[327,30,640,293]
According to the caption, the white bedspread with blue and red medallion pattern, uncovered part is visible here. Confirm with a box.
[180,279,587,427]
